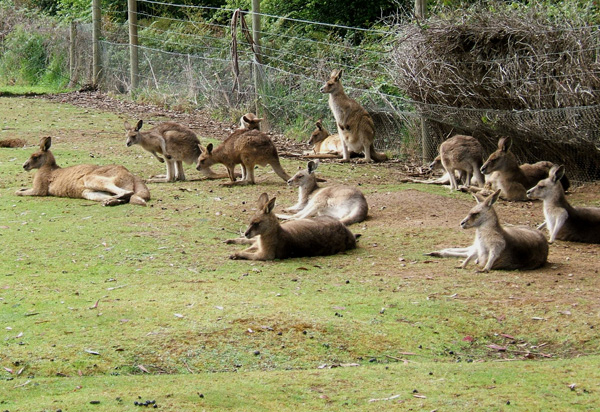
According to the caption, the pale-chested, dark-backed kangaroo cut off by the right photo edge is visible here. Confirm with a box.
[527,166,600,243]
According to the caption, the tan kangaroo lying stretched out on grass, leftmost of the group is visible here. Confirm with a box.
[16,137,150,206]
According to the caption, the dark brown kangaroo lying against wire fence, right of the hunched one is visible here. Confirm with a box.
[481,137,570,201]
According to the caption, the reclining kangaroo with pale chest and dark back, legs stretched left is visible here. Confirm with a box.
[427,190,548,272]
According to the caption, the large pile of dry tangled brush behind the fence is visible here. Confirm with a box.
[391,9,600,180]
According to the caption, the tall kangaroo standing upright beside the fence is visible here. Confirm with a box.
[321,70,387,162]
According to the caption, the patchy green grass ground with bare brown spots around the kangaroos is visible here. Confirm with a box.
[0,98,600,412]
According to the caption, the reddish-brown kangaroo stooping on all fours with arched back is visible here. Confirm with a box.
[196,129,290,184]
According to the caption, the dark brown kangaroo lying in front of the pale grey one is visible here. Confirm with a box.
[226,193,358,260]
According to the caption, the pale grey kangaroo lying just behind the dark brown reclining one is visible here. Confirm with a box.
[277,160,369,225]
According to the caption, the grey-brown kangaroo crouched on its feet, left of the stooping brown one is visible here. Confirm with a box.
[124,120,220,182]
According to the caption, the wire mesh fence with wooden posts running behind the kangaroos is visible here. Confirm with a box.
[64,0,600,180]
